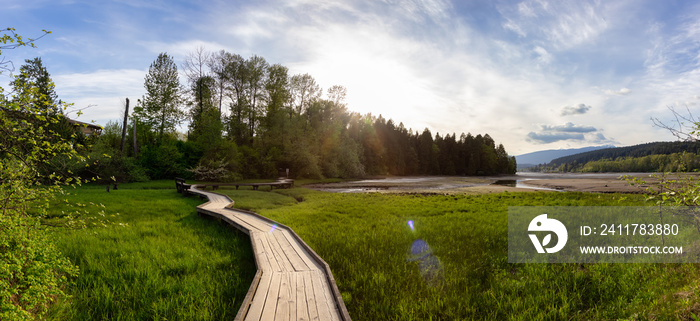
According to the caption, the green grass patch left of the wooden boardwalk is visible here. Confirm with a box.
[49,181,255,320]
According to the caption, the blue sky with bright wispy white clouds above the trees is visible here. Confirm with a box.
[0,0,700,155]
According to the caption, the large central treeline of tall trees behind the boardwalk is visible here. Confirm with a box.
[12,49,516,182]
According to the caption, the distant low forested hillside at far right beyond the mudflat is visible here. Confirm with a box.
[528,141,700,172]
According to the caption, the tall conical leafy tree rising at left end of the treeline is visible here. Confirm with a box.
[135,53,184,140]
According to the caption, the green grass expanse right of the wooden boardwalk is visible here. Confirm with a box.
[212,188,700,320]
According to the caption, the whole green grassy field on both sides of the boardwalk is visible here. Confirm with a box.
[52,181,700,320]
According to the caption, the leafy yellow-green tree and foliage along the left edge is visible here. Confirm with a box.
[0,28,85,320]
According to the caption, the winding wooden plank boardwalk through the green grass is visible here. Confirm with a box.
[189,185,350,321]
